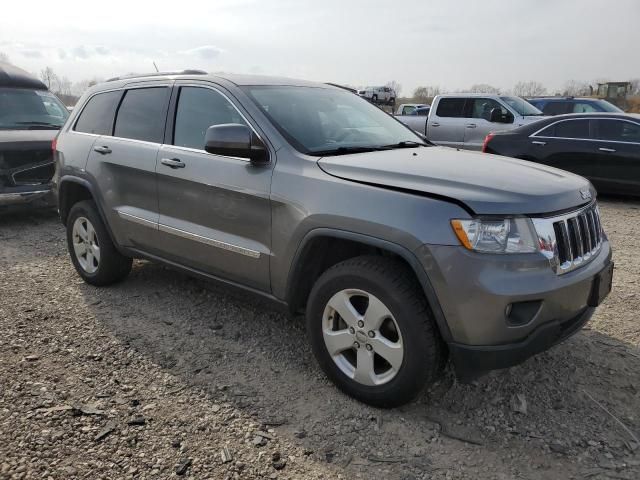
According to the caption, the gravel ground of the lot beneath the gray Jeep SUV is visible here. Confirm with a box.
[0,199,640,480]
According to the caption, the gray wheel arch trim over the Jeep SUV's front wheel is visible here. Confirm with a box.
[285,228,452,342]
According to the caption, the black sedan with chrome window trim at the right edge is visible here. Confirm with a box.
[482,113,640,195]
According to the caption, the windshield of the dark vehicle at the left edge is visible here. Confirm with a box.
[0,88,69,130]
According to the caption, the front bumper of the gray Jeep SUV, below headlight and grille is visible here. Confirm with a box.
[416,239,611,377]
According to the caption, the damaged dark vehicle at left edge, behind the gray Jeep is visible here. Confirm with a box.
[0,63,69,209]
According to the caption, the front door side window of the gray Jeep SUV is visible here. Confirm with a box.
[173,87,246,150]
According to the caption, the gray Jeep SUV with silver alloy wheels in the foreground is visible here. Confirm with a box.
[54,71,613,407]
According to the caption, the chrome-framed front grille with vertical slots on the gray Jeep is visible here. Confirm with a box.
[533,202,604,274]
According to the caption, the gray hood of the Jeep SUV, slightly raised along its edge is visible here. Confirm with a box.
[318,147,596,215]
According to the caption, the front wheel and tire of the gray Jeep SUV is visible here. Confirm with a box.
[307,256,443,407]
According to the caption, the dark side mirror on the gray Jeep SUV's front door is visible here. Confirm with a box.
[204,123,269,165]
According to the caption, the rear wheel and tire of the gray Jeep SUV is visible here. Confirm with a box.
[67,200,132,286]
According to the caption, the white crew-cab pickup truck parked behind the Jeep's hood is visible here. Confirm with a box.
[396,93,543,150]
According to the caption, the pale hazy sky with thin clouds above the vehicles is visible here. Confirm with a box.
[0,0,640,95]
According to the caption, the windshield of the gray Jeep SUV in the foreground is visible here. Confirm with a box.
[245,86,426,155]
